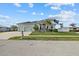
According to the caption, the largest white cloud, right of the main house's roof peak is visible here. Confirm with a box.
[54,11,77,22]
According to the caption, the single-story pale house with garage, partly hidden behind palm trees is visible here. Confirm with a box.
[17,19,56,32]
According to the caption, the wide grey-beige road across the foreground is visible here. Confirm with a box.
[0,40,79,56]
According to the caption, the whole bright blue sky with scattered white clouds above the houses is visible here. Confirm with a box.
[0,3,79,26]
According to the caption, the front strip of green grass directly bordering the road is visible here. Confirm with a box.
[9,36,79,41]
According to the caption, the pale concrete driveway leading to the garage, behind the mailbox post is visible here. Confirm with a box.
[0,32,31,40]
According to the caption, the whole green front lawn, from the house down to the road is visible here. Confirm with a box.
[9,32,79,41]
